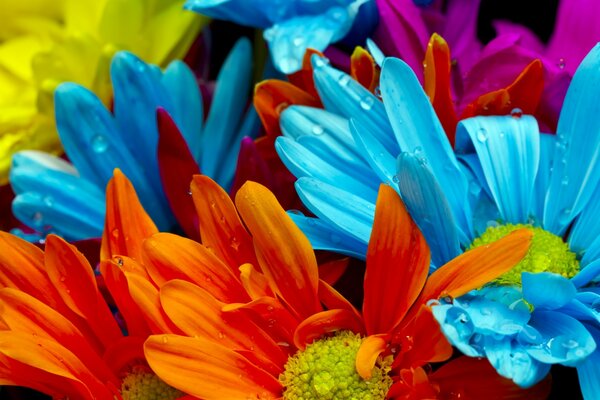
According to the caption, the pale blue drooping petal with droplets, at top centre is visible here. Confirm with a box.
[263,7,352,74]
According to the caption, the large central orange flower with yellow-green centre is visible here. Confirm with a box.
[96,170,547,399]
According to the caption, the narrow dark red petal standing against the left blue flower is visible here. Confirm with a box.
[156,108,200,240]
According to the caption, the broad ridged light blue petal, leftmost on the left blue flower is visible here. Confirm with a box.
[11,167,106,240]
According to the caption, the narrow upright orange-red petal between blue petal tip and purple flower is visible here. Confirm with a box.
[423,33,458,145]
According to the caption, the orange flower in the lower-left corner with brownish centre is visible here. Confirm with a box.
[0,173,188,400]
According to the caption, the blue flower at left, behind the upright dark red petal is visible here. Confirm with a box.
[10,39,259,240]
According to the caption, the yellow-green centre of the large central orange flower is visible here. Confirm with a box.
[279,331,392,400]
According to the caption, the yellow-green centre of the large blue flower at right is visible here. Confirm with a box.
[469,224,579,286]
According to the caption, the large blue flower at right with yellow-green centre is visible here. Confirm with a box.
[276,45,600,398]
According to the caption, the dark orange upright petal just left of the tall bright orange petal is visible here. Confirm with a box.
[191,175,257,274]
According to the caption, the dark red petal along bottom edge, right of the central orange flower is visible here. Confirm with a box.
[430,356,551,400]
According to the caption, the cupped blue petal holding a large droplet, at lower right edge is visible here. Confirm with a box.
[524,310,596,365]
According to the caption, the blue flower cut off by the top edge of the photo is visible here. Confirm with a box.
[185,0,379,74]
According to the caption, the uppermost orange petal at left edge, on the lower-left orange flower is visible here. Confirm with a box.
[0,231,66,310]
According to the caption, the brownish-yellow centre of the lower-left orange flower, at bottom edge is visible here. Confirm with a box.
[121,366,183,400]
